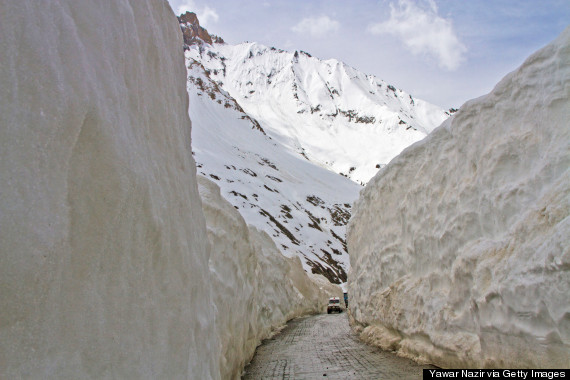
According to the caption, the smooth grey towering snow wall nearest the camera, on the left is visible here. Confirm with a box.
[0,0,219,379]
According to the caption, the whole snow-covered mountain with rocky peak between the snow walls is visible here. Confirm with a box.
[179,13,448,283]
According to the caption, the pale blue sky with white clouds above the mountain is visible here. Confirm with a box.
[169,0,570,109]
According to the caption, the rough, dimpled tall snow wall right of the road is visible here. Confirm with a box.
[348,28,570,368]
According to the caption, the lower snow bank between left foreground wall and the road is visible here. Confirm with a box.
[198,177,342,379]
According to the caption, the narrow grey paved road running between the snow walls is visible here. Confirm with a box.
[242,313,435,380]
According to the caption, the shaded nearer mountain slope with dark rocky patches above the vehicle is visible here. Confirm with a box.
[187,58,360,283]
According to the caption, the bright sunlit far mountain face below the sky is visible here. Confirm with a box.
[187,43,449,184]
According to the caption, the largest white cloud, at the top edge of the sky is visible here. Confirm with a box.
[368,0,467,70]
